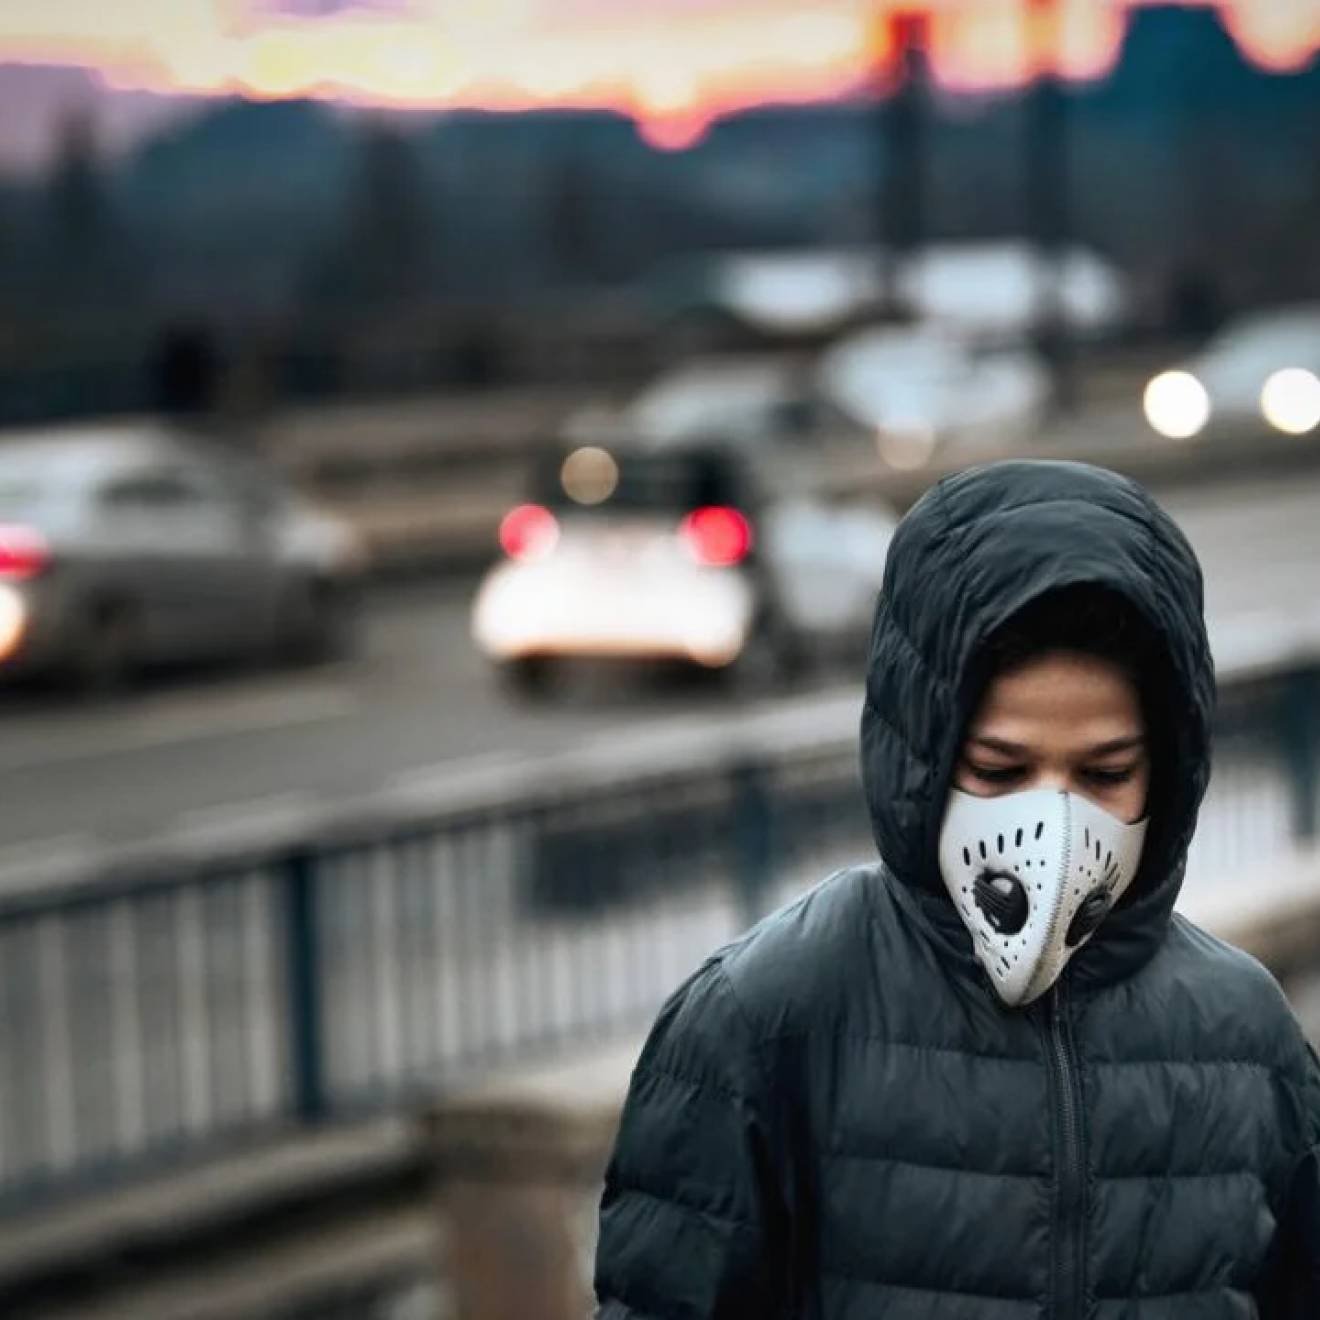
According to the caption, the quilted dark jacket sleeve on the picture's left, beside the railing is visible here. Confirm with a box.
[595,962,788,1320]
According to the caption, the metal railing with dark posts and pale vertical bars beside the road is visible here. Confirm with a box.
[0,665,1320,1209]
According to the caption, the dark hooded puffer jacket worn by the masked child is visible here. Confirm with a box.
[597,463,1320,1320]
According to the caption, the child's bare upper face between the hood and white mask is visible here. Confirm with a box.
[954,651,1150,824]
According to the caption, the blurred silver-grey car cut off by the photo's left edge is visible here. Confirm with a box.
[0,424,363,689]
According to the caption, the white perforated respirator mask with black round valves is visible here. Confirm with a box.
[940,788,1147,1007]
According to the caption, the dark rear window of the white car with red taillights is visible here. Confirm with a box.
[533,446,744,513]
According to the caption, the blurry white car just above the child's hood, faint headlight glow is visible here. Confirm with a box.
[820,327,1051,469]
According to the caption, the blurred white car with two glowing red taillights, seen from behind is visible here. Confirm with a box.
[473,445,895,692]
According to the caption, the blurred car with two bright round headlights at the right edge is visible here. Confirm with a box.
[1142,304,1320,440]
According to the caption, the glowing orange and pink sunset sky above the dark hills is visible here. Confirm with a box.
[0,0,1320,145]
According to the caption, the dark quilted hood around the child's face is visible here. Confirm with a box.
[861,461,1214,979]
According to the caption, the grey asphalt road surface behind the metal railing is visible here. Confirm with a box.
[0,474,1320,879]
